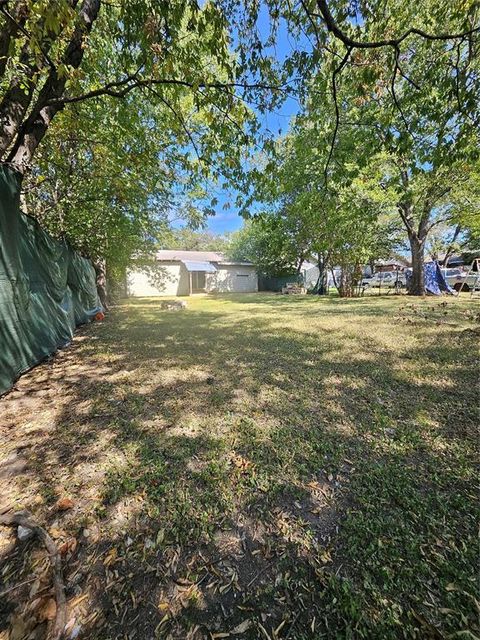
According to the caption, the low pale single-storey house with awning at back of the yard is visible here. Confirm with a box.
[127,249,258,297]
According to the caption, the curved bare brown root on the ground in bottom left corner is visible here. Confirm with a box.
[0,511,67,640]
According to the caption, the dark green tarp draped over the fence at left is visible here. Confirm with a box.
[0,166,101,394]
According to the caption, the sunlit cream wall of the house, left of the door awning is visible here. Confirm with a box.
[127,262,189,298]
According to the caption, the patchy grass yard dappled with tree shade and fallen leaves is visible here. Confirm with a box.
[0,295,480,640]
